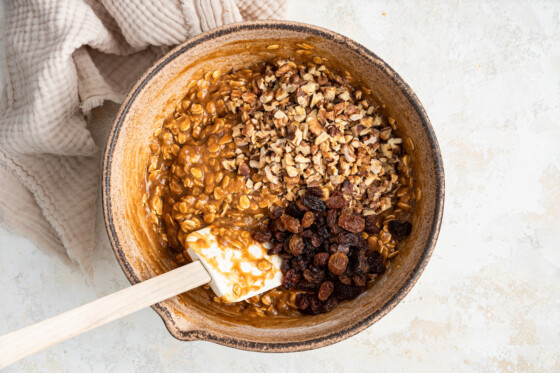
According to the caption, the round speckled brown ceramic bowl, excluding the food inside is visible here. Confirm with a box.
[103,21,444,352]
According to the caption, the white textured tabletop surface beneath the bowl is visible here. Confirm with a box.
[0,0,560,372]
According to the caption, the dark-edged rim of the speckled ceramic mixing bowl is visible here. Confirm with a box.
[102,20,445,352]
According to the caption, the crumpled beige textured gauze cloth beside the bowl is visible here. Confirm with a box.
[0,0,285,275]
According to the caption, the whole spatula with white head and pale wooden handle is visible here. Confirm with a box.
[0,227,282,369]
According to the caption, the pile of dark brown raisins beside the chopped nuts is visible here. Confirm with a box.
[254,187,412,315]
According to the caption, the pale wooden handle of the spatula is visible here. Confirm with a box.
[0,261,210,369]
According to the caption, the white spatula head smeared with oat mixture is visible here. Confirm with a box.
[186,226,282,303]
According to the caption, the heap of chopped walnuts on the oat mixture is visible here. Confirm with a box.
[224,58,402,213]
